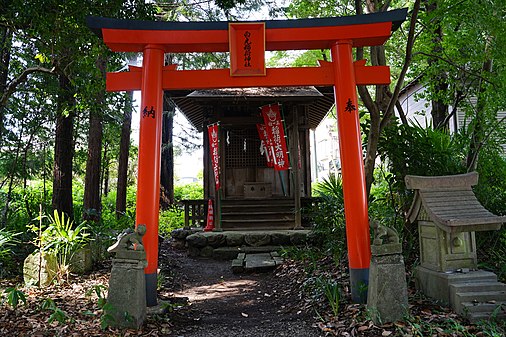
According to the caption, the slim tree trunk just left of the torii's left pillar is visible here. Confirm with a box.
[116,91,134,219]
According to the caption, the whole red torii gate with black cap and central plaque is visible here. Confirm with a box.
[87,9,407,306]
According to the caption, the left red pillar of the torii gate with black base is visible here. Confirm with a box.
[135,45,164,307]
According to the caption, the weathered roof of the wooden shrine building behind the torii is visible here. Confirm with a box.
[170,86,334,132]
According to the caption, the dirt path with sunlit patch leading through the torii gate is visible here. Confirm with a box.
[160,243,323,337]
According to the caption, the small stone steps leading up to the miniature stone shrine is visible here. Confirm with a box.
[450,280,506,322]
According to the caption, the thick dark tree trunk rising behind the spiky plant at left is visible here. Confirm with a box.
[53,74,75,218]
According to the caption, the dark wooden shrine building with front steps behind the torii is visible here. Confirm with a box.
[171,87,334,230]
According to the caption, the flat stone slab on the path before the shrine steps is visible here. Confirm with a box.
[232,252,283,273]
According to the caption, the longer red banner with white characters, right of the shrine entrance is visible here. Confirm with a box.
[262,104,290,171]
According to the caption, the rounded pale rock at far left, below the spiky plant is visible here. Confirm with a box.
[23,251,58,287]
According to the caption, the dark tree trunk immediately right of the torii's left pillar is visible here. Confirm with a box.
[160,94,175,209]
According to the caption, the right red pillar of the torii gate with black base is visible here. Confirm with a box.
[330,41,371,303]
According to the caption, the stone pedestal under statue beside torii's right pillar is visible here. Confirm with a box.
[367,243,408,324]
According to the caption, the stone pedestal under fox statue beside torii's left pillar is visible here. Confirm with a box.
[107,259,146,329]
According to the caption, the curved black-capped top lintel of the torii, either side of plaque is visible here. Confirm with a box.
[87,8,407,53]
